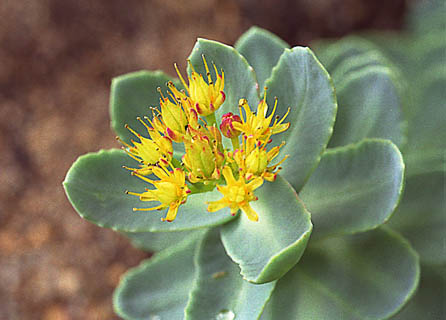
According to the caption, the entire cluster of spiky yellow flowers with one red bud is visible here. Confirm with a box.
[118,56,289,221]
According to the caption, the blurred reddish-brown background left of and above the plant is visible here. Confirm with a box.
[0,0,408,320]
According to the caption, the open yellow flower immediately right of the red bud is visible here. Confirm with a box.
[233,88,290,142]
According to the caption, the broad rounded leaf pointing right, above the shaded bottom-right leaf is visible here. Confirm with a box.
[299,140,404,237]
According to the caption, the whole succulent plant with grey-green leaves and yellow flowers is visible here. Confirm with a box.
[64,28,419,319]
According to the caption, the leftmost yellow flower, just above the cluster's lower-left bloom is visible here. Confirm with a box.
[116,117,173,175]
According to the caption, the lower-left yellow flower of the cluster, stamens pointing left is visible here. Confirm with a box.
[126,167,190,222]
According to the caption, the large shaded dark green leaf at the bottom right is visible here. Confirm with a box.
[261,229,419,320]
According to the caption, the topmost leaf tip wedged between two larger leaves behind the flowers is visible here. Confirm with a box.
[234,27,289,92]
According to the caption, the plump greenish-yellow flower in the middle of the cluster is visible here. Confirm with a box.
[183,126,224,183]
